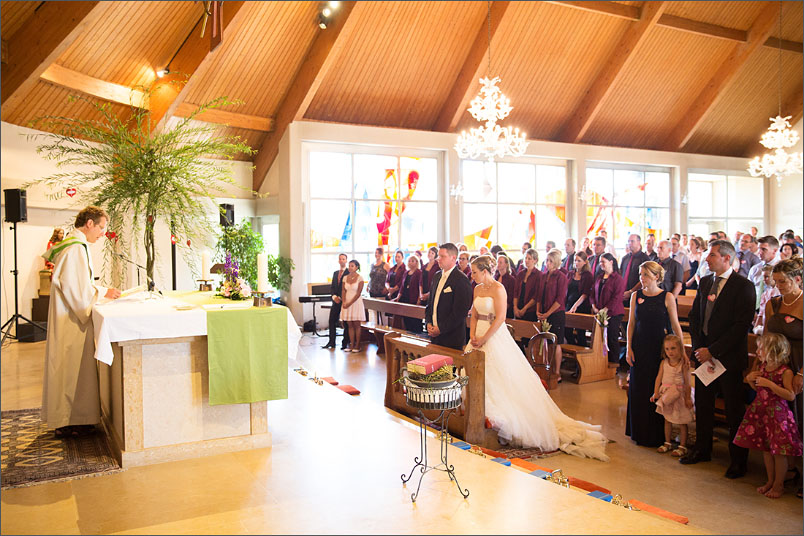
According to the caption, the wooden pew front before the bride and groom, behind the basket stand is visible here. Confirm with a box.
[384,332,499,449]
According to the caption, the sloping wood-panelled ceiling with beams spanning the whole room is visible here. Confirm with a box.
[0,1,804,186]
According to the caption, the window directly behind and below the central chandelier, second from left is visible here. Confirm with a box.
[461,160,567,253]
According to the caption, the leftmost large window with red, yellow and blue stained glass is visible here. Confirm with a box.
[309,151,438,281]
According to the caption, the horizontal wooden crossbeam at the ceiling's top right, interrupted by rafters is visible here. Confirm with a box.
[549,0,804,54]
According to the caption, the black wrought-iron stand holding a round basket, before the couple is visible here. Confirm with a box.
[401,372,469,502]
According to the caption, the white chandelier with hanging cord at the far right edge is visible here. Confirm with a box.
[748,1,801,186]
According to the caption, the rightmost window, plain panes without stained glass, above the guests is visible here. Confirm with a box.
[687,172,765,238]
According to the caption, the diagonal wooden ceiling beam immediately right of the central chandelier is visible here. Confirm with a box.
[558,2,667,143]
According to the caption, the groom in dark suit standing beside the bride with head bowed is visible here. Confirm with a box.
[425,242,472,350]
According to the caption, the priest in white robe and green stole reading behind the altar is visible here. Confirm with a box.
[42,206,120,437]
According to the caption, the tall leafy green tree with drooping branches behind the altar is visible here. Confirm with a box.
[26,89,256,280]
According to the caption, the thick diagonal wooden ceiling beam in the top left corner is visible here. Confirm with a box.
[0,2,111,116]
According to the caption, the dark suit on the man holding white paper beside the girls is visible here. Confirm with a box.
[689,272,756,465]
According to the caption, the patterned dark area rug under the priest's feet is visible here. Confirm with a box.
[0,408,122,489]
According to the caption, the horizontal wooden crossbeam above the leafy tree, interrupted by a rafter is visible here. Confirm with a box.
[41,63,273,132]
